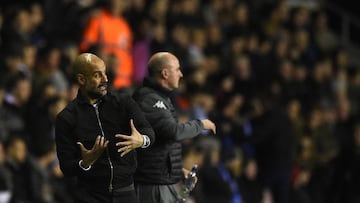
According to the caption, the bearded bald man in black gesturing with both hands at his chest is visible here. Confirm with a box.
[55,53,154,203]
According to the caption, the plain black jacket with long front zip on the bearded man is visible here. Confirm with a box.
[55,92,154,191]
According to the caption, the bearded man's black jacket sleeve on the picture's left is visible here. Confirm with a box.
[55,109,81,176]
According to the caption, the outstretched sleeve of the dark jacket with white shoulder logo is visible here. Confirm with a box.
[139,94,203,141]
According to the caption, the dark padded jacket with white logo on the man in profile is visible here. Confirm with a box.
[133,78,203,185]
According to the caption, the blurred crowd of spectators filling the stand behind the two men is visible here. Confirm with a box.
[0,0,360,203]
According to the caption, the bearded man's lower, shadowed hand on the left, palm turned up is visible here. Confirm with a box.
[77,135,109,168]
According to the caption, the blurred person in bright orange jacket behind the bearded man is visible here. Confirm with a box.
[80,0,134,89]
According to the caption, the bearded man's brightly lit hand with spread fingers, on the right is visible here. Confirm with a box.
[115,119,144,156]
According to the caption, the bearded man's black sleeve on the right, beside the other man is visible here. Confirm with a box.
[126,96,155,146]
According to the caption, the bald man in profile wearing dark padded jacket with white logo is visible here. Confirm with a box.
[133,52,216,203]
